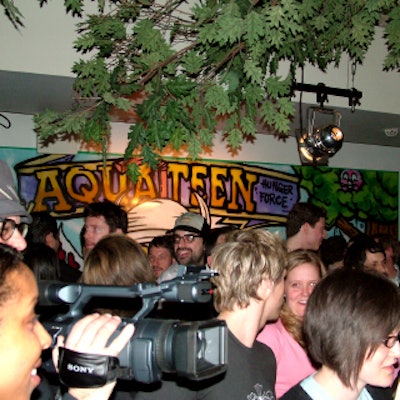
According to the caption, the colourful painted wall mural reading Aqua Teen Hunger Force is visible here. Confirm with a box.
[0,148,398,265]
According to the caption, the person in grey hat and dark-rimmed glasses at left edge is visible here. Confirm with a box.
[0,160,32,251]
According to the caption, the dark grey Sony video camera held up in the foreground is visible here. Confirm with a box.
[39,266,227,387]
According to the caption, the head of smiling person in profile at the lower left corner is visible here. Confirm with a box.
[0,245,51,400]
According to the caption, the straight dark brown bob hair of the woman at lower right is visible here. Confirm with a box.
[304,269,400,388]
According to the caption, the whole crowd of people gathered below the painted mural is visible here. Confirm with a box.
[0,157,400,400]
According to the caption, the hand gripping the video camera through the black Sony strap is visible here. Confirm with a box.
[53,314,134,400]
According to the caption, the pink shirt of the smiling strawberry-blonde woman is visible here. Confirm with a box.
[257,320,315,398]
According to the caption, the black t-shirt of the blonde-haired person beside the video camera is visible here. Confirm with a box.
[133,332,276,400]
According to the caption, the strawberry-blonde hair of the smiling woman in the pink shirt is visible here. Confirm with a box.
[280,249,327,348]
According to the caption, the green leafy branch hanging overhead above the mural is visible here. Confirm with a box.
[19,0,400,179]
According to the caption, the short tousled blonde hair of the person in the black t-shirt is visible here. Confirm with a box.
[211,229,287,312]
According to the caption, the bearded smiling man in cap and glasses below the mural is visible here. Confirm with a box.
[159,212,210,282]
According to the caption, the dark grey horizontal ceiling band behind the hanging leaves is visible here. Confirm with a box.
[0,71,400,147]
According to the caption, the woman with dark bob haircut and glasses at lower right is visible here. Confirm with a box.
[282,269,400,400]
